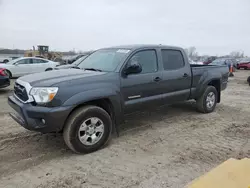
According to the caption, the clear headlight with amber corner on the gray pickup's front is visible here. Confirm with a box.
[30,87,58,103]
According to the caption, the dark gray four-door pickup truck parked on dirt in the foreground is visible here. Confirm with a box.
[8,45,228,153]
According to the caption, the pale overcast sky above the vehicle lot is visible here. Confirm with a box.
[0,0,250,56]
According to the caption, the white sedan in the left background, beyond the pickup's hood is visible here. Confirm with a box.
[0,57,60,78]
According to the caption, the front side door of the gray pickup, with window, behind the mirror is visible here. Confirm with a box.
[121,49,162,113]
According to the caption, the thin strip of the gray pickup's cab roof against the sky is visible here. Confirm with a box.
[102,44,182,50]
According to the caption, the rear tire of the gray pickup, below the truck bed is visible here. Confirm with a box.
[196,86,218,113]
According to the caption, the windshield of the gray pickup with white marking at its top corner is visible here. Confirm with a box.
[78,49,130,72]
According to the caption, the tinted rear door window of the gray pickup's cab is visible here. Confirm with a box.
[161,49,185,70]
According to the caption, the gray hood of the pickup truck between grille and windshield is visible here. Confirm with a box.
[19,69,106,87]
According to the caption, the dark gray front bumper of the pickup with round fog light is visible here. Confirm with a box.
[8,96,73,133]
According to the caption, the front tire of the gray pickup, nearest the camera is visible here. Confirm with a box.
[63,106,112,153]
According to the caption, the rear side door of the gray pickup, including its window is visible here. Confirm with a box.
[161,49,192,104]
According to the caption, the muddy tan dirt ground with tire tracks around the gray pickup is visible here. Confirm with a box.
[0,70,250,188]
